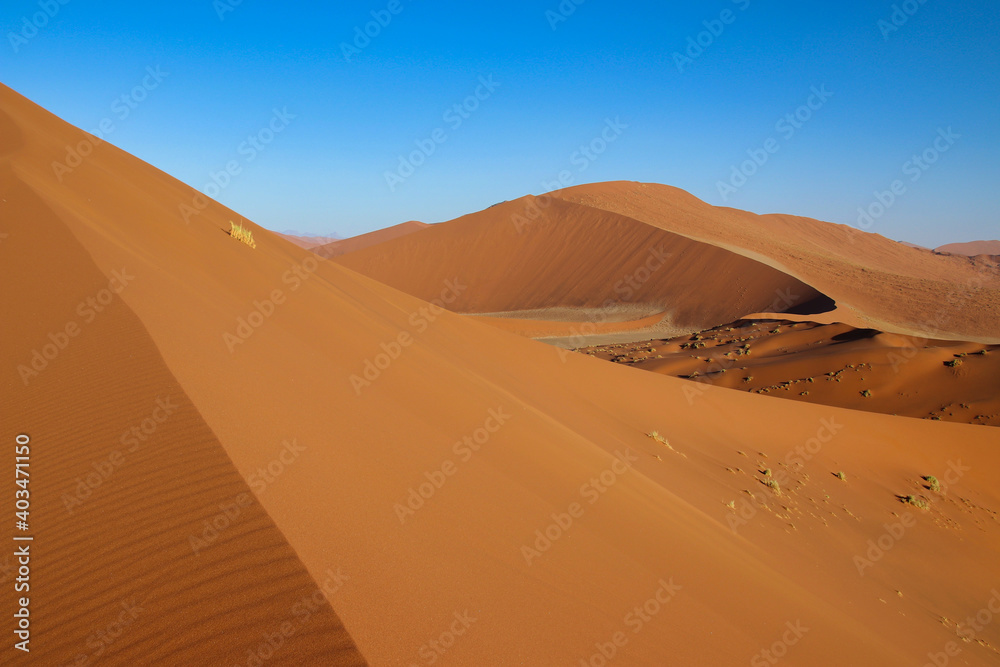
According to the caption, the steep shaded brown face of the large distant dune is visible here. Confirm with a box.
[337,197,821,328]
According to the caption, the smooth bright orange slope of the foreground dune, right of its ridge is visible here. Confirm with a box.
[0,89,1000,667]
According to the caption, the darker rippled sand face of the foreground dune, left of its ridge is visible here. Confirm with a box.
[0,171,364,665]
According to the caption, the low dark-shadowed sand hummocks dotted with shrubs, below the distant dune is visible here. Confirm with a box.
[579,319,1000,426]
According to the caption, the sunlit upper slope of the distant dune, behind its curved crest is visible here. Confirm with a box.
[551,181,1000,343]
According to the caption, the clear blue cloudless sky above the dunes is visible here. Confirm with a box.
[0,0,1000,247]
